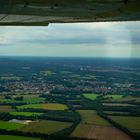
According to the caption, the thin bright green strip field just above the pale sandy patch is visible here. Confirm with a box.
[10,112,43,117]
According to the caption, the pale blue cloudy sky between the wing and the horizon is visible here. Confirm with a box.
[0,21,140,58]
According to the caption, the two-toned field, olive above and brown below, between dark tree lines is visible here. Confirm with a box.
[71,110,131,140]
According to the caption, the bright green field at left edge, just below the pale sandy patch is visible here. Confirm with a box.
[0,121,24,130]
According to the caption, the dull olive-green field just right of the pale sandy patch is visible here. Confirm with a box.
[21,120,71,134]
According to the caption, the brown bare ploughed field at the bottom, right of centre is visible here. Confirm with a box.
[71,124,131,140]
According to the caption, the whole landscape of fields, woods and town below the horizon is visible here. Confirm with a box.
[0,58,140,140]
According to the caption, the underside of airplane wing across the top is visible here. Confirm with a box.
[0,0,140,26]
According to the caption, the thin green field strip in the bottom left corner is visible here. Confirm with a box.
[0,135,41,140]
